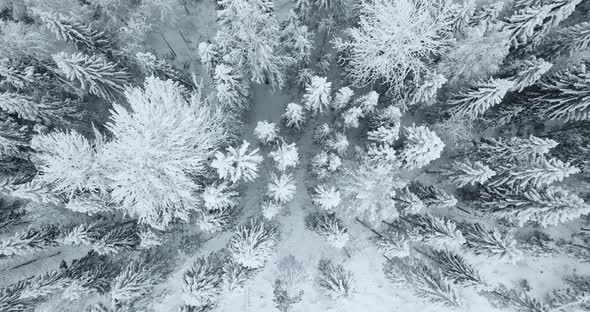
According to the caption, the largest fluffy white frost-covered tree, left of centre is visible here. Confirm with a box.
[100,77,228,227]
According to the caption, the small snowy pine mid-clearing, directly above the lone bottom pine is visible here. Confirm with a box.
[305,212,350,249]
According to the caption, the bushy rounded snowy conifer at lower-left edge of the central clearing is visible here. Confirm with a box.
[228,218,279,269]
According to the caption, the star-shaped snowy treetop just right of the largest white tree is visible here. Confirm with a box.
[211,141,263,183]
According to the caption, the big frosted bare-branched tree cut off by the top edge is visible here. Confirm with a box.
[334,0,452,92]
